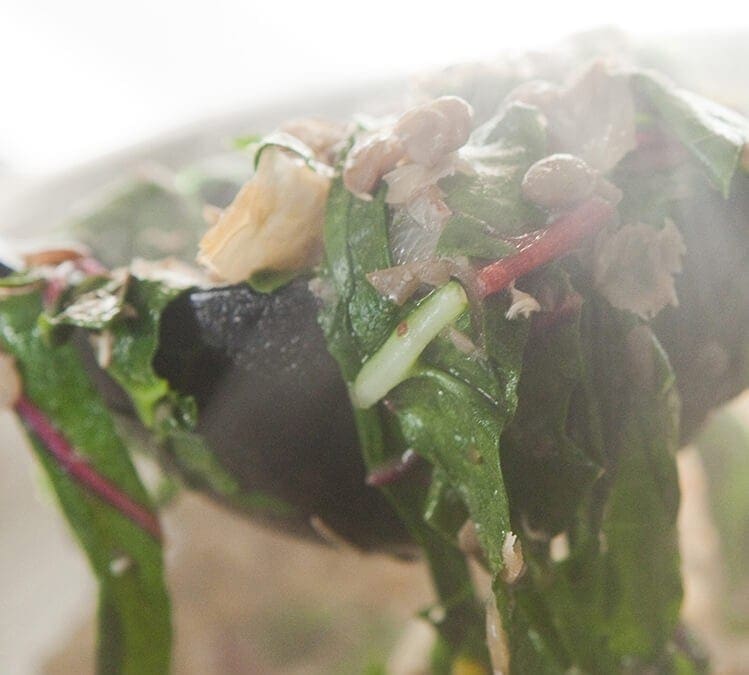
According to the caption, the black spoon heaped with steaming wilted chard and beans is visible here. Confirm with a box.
[0,54,749,673]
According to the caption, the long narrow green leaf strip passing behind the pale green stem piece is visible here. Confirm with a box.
[320,181,487,663]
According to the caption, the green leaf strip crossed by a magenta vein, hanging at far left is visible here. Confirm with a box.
[0,293,171,675]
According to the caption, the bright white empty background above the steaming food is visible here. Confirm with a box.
[0,0,749,174]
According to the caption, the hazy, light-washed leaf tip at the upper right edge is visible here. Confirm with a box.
[632,72,749,197]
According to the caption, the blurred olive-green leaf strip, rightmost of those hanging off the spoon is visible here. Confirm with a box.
[601,323,681,659]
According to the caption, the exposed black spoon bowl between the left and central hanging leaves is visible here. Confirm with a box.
[79,279,410,555]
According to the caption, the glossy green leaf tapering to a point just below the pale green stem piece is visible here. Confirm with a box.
[389,298,528,574]
